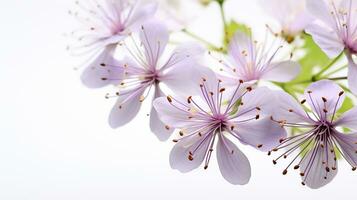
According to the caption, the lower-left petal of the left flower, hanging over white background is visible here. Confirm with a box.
[109,90,144,128]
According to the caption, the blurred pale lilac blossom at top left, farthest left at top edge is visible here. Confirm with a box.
[68,0,157,71]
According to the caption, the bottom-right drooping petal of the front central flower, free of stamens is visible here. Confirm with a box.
[217,135,251,185]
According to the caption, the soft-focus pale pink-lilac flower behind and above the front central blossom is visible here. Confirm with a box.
[220,32,300,84]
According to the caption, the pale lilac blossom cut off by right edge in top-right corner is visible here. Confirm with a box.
[306,0,357,93]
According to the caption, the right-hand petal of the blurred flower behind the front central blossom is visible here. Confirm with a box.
[261,61,300,82]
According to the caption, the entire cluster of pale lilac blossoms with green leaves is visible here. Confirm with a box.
[68,0,357,189]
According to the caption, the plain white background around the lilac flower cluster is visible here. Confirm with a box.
[0,0,357,200]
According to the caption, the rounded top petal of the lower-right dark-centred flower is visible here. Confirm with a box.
[305,80,345,117]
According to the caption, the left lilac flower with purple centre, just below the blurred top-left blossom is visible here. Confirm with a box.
[82,21,206,140]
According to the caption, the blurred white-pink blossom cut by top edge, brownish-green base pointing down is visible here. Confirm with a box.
[259,0,311,43]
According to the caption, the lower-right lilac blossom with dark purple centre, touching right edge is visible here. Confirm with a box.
[269,80,357,189]
